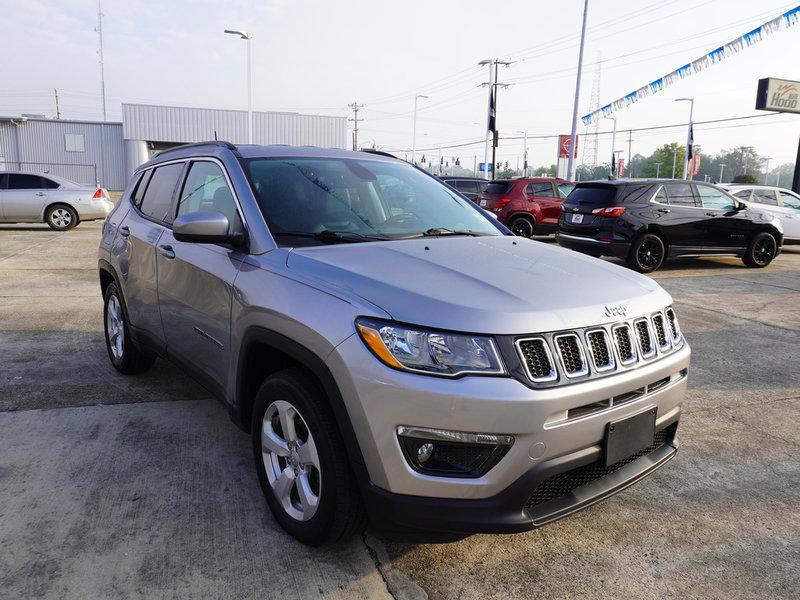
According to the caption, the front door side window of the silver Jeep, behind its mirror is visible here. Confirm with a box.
[178,161,242,233]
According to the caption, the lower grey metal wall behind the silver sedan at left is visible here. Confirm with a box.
[0,119,127,190]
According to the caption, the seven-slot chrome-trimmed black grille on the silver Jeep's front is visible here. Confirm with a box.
[516,308,681,383]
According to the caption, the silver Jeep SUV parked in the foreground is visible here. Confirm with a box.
[99,142,690,544]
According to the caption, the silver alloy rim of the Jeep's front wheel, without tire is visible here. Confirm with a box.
[261,400,322,521]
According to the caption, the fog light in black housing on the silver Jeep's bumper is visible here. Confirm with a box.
[397,426,514,477]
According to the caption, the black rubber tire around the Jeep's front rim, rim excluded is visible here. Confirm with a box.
[251,368,366,546]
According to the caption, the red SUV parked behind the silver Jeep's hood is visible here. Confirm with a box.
[477,177,575,237]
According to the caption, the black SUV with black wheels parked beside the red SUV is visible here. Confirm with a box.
[556,179,783,273]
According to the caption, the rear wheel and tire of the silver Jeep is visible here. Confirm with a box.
[103,283,156,375]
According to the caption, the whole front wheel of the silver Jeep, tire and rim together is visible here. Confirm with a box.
[251,368,365,546]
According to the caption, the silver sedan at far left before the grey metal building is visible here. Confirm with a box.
[0,171,114,231]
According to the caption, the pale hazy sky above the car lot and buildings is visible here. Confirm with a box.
[0,0,800,167]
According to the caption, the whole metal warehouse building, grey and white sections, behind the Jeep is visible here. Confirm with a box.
[0,104,347,190]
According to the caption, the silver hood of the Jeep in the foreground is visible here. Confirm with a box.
[286,236,672,334]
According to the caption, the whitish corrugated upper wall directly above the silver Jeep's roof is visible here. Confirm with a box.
[122,104,347,148]
